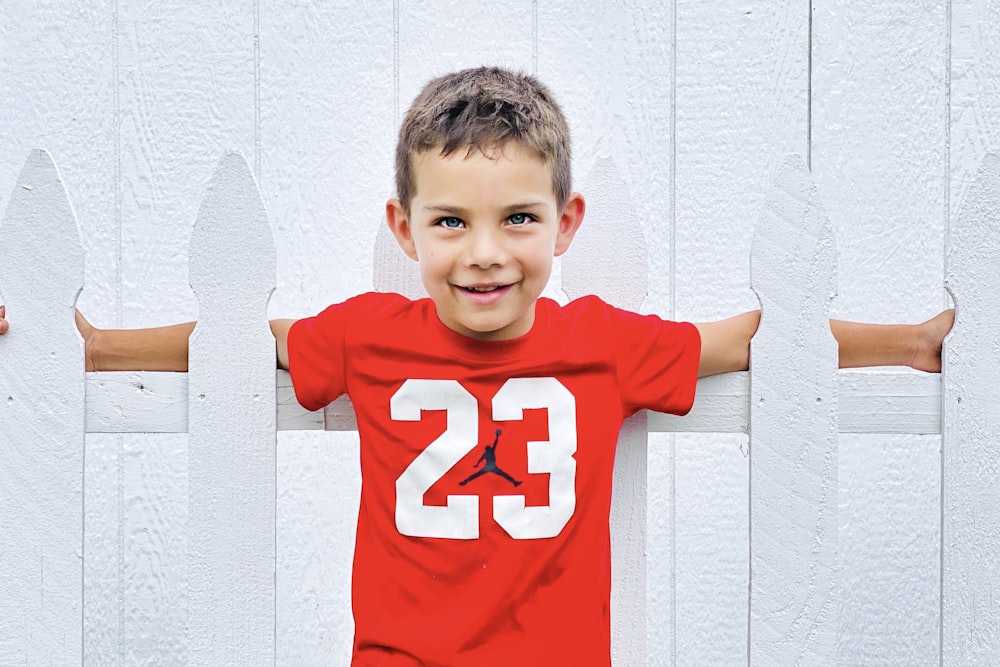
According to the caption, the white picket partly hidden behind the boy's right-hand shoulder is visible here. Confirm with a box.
[562,159,647,665]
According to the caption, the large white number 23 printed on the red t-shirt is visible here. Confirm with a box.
[390,377,576,540]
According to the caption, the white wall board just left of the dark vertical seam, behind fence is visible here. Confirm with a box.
[674,0,810,665]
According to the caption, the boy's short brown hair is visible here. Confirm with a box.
[396,67,572,211]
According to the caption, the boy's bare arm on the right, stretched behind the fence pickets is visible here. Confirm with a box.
[695,310,955,377]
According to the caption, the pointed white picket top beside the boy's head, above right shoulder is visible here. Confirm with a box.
[562,158,649,311]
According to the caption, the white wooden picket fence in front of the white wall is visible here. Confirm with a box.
[0,151,1000,665]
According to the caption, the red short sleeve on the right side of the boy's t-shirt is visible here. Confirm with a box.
[613,309,701,415]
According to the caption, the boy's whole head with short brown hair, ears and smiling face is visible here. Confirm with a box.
[386,68,585,340]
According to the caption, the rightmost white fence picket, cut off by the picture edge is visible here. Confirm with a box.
[941,154,1000,665]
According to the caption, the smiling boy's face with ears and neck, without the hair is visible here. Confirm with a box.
[386,143,584,340]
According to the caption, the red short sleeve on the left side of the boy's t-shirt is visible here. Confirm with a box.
[288,301,351,410]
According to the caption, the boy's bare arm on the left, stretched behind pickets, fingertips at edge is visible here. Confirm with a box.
[0,306,295,371]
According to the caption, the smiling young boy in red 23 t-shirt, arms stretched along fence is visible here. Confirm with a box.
[0,68,952,667]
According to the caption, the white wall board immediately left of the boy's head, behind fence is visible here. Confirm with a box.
[256,0,394,665]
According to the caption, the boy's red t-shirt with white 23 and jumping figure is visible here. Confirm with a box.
[288,293,700,667]
